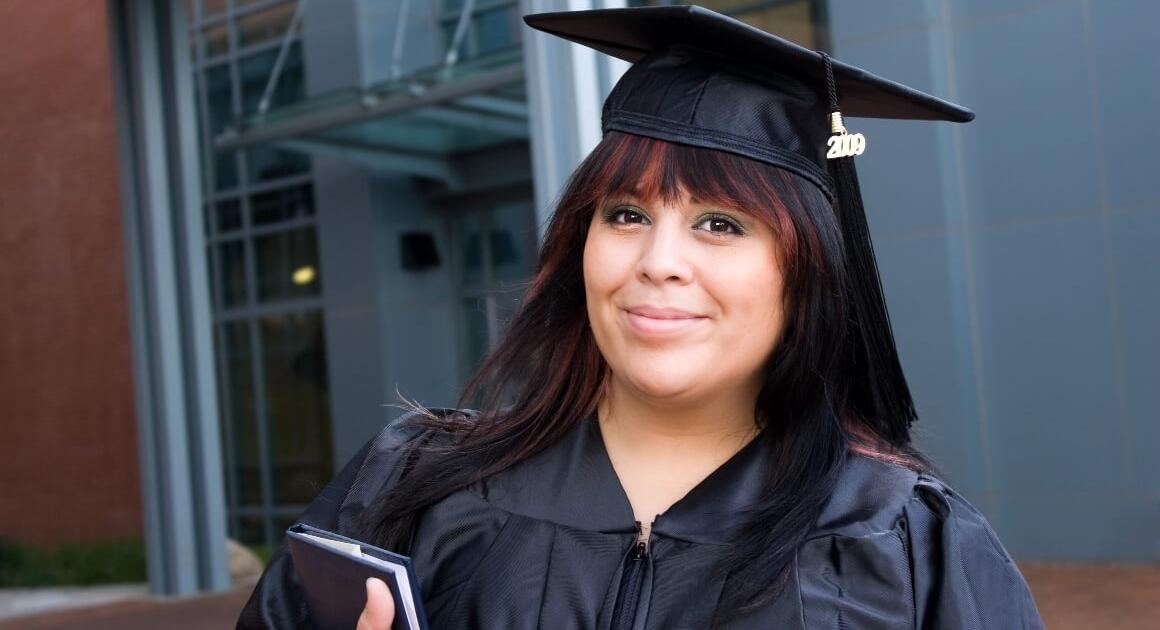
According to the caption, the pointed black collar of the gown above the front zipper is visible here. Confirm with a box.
[481,415,770,544]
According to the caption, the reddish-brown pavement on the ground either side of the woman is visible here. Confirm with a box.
[0,563,1160,630]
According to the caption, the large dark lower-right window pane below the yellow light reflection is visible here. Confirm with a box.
[260,311,333,505]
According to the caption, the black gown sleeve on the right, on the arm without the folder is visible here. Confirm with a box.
[905,477,1043,630]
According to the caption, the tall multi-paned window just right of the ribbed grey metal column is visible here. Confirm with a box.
[181,0,322,544]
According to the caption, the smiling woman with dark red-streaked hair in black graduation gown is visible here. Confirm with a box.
[239,7,1042,629]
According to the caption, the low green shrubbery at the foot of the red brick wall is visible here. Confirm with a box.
[0,538,145,587]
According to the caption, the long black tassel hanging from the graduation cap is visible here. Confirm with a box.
[822,55,918,444]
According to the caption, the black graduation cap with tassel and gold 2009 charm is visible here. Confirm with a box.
[524,6,974,444]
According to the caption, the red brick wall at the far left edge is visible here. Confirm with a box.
[0,0,142,543]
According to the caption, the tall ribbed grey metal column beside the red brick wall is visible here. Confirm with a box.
[109,0,229,594]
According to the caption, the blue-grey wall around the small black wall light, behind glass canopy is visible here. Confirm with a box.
[303,0,459,466]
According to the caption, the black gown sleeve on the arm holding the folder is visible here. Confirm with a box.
[237,418,436,630]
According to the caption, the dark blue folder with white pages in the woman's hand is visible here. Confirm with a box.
[287,523,428,630]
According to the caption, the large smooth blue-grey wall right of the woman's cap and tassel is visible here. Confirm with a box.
[829,0,1160,562]
